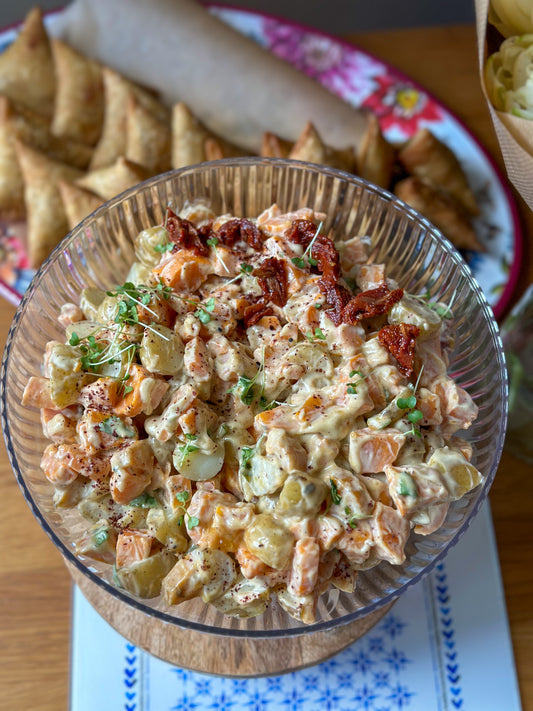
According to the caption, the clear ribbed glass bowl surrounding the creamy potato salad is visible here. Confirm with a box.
[0,158,507,637]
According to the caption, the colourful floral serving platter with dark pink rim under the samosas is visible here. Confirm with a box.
[0,5,522,317]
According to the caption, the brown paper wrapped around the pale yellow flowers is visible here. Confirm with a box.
[476,0,533,210]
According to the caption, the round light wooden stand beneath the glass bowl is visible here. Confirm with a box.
[67,563,393,678]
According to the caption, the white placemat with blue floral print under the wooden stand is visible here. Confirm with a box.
[71,504,521,711]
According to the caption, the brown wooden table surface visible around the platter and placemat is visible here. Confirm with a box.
[0,26,533,711]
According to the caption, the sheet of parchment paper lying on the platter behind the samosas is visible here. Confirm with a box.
[53,0,366,152]
